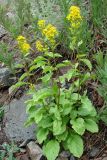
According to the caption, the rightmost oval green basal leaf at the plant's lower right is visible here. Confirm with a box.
[85,118,98,133]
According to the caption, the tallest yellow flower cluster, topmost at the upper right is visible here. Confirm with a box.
[67,6,82,28]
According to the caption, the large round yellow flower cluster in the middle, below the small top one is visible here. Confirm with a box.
[42,24,58,40]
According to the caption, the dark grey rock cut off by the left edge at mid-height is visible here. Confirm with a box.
[0,68,14,88]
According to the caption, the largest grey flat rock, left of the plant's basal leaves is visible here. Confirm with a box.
[3,95,36,142]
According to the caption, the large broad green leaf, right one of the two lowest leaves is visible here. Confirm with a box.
[67,133,83,158]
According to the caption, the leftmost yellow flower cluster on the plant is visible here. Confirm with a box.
[17,35,31,53]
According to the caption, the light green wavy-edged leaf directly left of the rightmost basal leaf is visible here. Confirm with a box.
[70,118,85,135]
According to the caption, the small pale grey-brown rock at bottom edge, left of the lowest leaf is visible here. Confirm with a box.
[27,141,43,160]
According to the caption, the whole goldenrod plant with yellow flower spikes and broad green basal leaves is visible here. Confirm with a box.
[10,6,98,160]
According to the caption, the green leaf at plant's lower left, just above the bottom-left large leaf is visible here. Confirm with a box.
[37,128,49,144]
